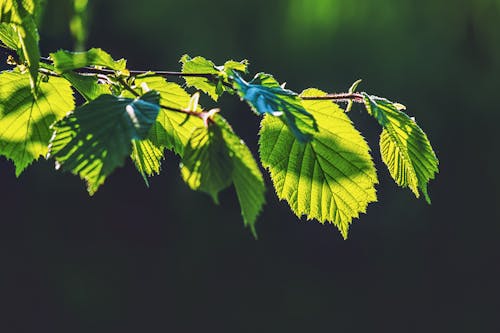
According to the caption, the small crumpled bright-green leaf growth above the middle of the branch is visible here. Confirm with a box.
[180,54,248,101]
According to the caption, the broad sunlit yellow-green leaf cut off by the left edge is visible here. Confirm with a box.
[0,71,74,176]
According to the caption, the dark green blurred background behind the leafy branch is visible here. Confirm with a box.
[0,0,500,332]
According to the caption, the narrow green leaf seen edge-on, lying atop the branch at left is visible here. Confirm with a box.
[50,48,127,73]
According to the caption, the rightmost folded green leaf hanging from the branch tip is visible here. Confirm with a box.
[363,93,439,204]
